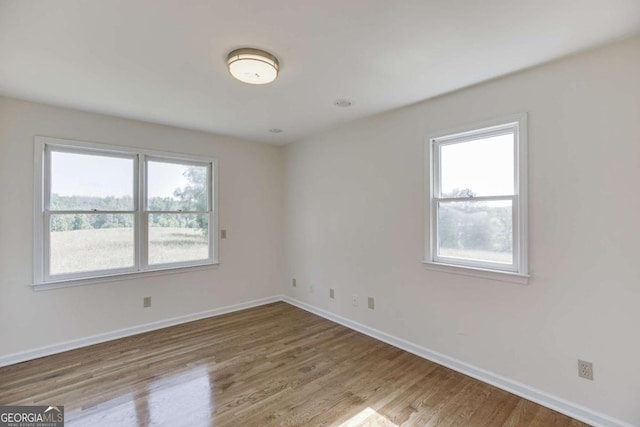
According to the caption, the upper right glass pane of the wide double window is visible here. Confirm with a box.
[147,161,209,211]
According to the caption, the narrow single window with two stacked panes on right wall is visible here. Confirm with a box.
[425,114,527,281]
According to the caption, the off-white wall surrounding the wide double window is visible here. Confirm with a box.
[0,97,283,356]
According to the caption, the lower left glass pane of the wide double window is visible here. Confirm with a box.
[49,214,134,275]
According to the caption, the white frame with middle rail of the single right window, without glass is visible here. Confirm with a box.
[423,113,529,284]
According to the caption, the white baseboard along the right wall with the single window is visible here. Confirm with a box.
[282,295,634,427]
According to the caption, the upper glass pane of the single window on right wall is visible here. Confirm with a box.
[440,133,514,197]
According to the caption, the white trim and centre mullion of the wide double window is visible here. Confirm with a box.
[32,136,219,290]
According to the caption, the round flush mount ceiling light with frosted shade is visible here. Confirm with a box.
[227,48,280,85]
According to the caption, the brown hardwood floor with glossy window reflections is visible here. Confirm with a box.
[0,303,585,426]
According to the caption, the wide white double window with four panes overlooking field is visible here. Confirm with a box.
[34,137,217,285]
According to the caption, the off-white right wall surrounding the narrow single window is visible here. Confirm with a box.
[285,37,640,425]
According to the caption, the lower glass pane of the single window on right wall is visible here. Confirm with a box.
[438,200,513,264]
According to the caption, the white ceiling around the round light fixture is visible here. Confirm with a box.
[0,0,640,144]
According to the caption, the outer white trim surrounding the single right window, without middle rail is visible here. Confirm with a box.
[423,113,530,284]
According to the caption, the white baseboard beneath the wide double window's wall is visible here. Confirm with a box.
[0,295,282,367]
